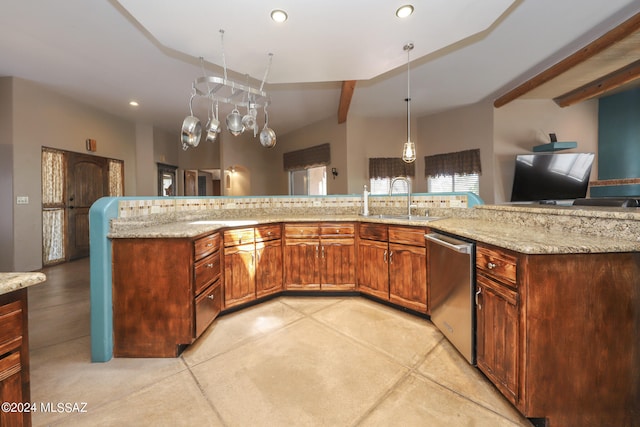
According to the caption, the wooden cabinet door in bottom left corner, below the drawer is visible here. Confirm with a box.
[0,352,25,426]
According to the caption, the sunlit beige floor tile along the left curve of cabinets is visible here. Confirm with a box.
[182,300,303,366]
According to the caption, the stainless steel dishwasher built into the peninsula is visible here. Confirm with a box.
[424,233,476,365]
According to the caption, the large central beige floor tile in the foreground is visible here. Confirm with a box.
[192,318,407,426]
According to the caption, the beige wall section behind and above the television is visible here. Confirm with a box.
[492,99,598,203]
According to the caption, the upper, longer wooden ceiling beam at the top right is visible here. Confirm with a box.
[493,13,640,108]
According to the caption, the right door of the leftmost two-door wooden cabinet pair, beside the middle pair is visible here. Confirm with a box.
[256,240,282,298]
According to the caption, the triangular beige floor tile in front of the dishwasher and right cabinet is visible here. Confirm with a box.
[418,340,522,422]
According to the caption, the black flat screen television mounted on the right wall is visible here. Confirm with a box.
[511,153,594,202]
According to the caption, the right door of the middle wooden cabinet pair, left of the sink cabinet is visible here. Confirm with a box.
[320,238,356,290]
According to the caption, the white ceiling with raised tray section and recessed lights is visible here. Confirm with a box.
[0,0,640,135]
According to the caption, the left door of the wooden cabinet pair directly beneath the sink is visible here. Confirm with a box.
[358,240,389,300]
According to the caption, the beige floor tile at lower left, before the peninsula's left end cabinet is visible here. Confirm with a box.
[30,337,186,425]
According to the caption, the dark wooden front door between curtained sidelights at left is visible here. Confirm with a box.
[65,152,109,261]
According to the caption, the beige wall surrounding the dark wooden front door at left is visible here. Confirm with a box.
[7,77,136,271]
